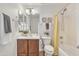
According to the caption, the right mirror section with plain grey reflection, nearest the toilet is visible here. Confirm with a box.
[29,14,40,34]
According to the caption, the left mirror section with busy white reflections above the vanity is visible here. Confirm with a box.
[18,14,29,34]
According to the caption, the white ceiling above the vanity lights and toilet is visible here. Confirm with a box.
[19,3,66,14]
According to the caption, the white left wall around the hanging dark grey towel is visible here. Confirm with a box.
[0,4,19,56]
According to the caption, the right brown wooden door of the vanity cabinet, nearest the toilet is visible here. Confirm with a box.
[29,39,39,56]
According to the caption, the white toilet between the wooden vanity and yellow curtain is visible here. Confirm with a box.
[42,37,54,56]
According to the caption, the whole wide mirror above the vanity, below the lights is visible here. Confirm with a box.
[18,9,40,34]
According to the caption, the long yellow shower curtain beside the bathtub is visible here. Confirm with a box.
[53,15,59,56]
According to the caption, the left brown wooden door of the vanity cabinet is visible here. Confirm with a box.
[17,39,28,56]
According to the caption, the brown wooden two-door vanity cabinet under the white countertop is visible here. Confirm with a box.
[17,39,39,56]
